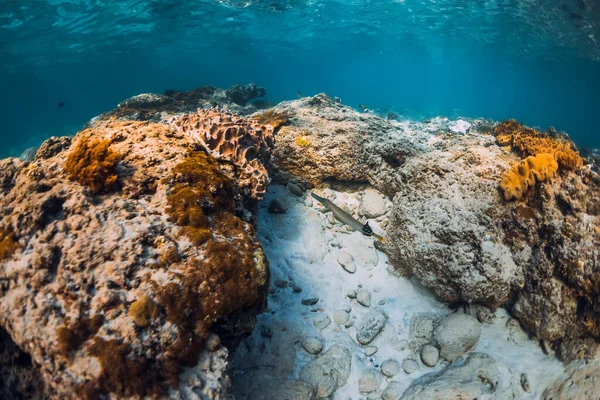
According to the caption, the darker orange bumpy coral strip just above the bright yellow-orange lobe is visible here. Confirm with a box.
[494,120,583,170]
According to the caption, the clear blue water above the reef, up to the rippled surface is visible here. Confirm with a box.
[0,0,600,157]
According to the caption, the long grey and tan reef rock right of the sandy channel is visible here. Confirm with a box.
[272,94,600,340]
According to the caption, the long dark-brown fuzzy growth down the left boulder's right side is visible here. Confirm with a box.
[155,152,266,382]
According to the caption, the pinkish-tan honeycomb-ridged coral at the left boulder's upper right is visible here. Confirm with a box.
[169,109,275,200]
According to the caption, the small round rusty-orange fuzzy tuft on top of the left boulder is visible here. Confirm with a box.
[64,137,120,194]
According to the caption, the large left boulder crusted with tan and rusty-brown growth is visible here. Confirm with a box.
[0,111,268,398]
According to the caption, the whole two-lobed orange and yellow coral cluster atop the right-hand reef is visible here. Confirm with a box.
[494,120,583,200]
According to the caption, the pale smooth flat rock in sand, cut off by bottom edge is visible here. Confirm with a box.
[401,353,524,400]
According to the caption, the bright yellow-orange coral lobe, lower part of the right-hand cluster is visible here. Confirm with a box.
[500,154,558,200]
